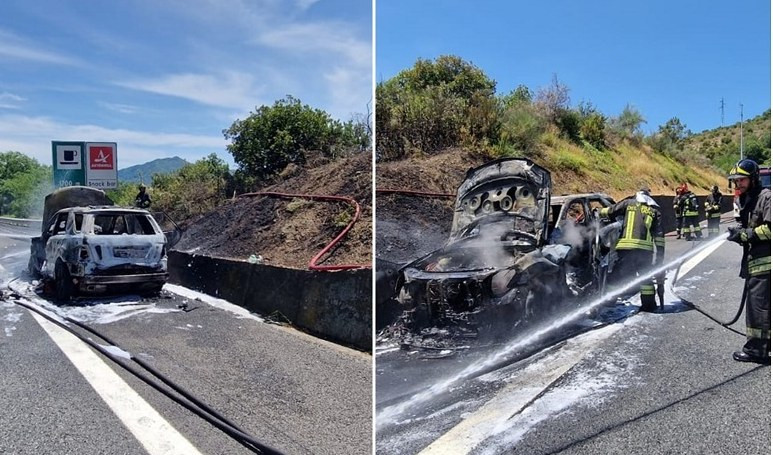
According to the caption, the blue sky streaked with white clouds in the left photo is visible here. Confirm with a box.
[0,0,372,168]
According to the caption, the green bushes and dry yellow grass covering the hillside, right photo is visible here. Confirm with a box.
[376,56,770,195]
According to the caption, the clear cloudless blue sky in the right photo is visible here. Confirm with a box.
[376,0,771,137]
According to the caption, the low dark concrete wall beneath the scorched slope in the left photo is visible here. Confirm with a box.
[168,251,373,351]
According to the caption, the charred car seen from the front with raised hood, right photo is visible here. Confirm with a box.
[387,159,619,342]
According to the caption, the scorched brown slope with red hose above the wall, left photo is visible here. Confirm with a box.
[174,152,373,269]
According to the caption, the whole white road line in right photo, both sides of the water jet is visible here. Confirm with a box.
[420,242,724,455]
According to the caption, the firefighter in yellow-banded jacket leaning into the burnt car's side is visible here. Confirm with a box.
[600,191,666,311]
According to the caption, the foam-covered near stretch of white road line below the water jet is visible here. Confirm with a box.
[419,325,621,455]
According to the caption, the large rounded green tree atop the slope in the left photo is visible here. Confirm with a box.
[223,95,358,180]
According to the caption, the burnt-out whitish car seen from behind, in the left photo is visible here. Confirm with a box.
[30,187,169,300]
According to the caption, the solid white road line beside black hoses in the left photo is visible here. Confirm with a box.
[31,312,201,455]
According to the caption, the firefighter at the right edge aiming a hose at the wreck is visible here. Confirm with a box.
[728,159,770,364]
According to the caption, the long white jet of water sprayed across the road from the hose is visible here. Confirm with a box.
[376,235,728,429]
